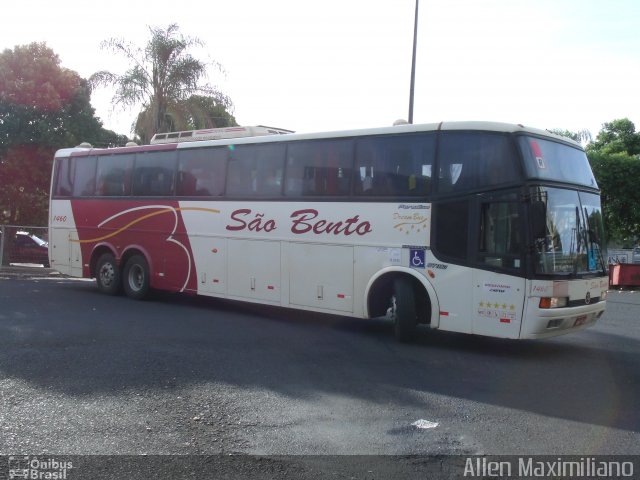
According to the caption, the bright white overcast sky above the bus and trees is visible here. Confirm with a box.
[0,0,640,137]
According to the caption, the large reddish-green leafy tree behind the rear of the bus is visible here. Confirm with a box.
[0,43,118,225]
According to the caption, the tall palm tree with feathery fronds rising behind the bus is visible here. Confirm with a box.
[90,24,232,143]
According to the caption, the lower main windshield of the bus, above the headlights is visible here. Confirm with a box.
[535,187,606,274]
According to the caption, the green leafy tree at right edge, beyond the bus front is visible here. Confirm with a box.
[587,118,640,247]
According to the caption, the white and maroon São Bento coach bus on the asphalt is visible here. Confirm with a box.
[49,122,608,341]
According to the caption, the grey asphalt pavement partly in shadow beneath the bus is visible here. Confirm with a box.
[0,269,640,472]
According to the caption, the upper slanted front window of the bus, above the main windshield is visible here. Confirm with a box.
[518,136,598,188]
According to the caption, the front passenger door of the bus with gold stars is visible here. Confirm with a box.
[472,193,525,338]
